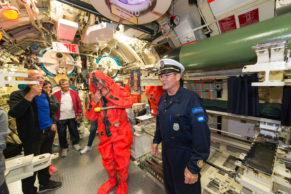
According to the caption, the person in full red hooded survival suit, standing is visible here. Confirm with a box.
[87,70,133,194]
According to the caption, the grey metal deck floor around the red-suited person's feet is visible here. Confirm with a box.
[8,138,165,194]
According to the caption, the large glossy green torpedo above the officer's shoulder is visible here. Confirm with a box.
[163,13,291,70]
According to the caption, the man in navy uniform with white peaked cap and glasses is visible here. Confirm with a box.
[152,59,210,194]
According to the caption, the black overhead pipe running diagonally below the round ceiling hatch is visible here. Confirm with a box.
[57,0,154,35]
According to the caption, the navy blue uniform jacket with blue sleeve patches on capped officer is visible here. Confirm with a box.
[153,87,210,174]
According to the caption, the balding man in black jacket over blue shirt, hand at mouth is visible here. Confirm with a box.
[8,70,62,194]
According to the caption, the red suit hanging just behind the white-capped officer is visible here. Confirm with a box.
[145,86,164,116]
